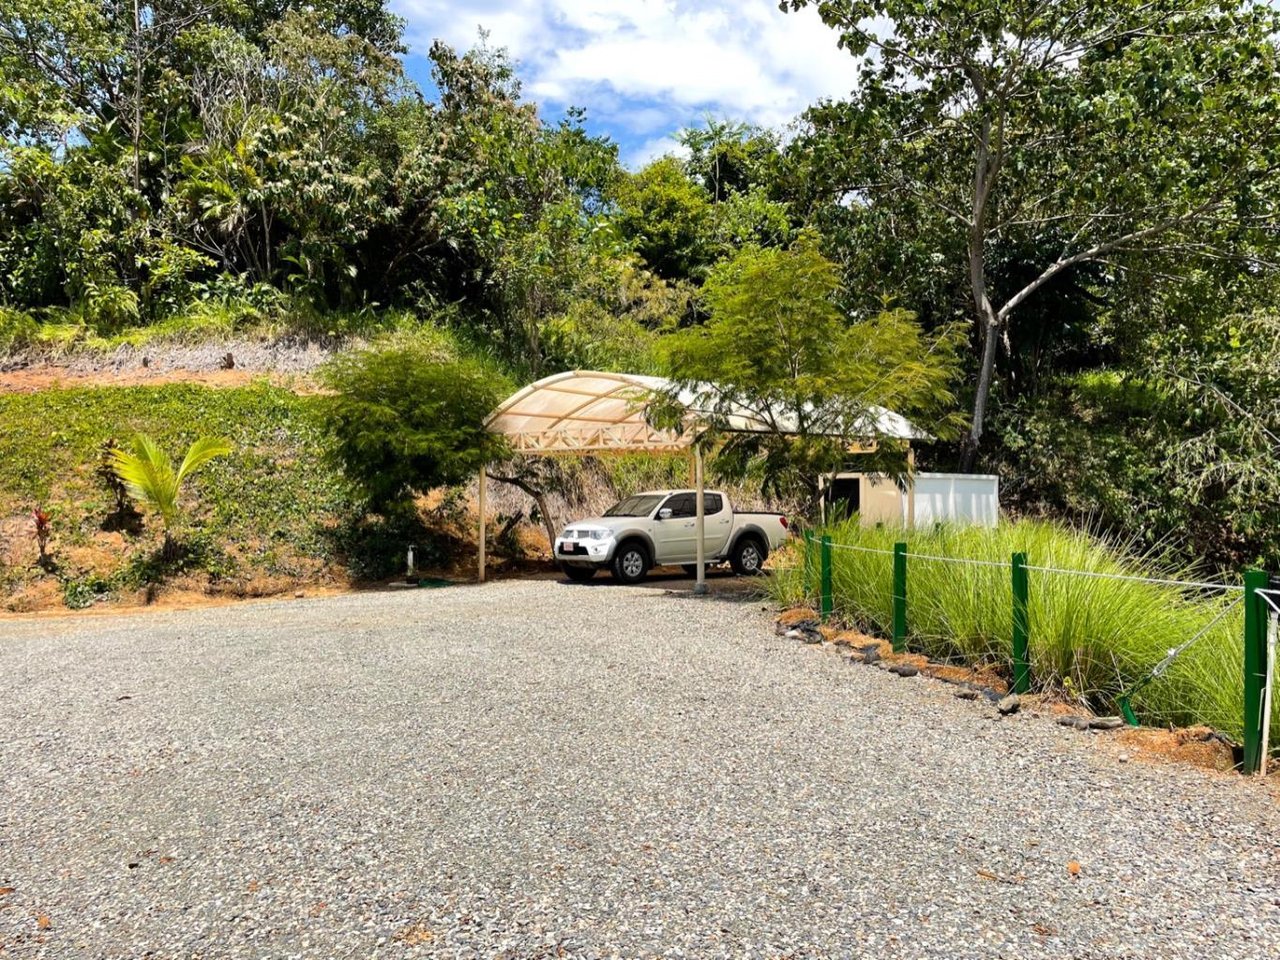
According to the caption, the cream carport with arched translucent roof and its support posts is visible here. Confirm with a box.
[479,370,925,593]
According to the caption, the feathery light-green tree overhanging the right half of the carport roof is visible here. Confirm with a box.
[650,232,956,504]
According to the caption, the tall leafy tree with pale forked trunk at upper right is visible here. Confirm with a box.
[780,0,1280,468]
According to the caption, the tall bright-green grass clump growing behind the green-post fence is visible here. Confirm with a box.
[773,517,1259,740]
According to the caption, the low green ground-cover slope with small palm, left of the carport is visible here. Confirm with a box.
[0,383,476,609]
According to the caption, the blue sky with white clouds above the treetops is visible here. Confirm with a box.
[390,0,855,166]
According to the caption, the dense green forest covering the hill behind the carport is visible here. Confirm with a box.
[0,0,1280,567]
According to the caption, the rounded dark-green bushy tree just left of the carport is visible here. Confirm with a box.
[320,338,506,511]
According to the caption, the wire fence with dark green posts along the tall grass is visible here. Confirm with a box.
[803,532,1280,772]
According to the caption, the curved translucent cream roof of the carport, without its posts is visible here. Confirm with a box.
[486,370,927,453]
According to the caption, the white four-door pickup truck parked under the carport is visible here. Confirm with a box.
[556,490,787,584]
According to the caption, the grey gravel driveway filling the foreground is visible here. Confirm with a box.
[0,581,1280,960]
